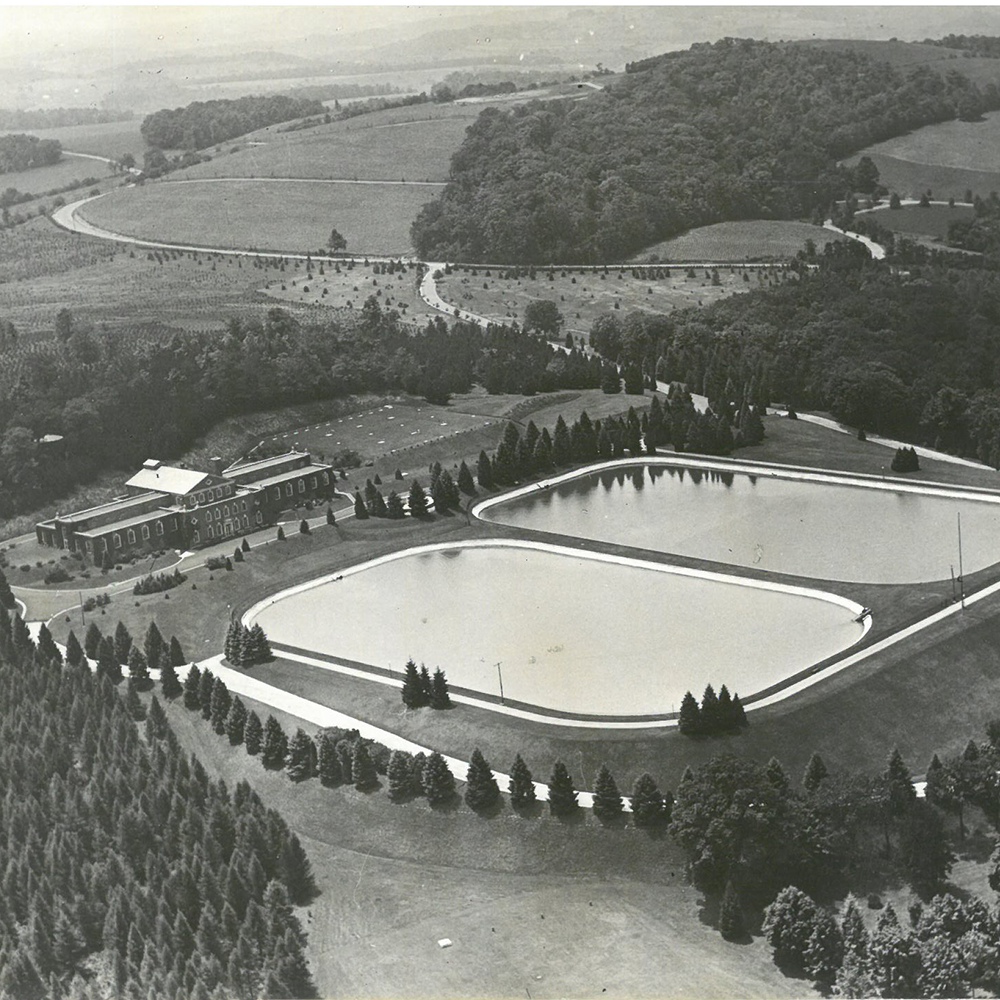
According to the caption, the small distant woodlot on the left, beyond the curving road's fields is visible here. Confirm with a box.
[140,94,326,149]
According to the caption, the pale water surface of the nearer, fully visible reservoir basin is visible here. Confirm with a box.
[257,544,861,715]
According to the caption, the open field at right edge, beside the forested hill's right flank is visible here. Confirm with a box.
[845,112,1000,200]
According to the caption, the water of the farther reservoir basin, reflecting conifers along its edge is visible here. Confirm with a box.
[483,465,1000,583]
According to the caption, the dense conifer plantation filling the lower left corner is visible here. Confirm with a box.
[0,608,316,1000]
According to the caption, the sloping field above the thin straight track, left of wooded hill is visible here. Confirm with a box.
[180,104,482,181]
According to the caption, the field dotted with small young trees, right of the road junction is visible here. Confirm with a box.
[437,267,795,336]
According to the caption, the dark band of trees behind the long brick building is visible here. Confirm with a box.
[0,297,602,517]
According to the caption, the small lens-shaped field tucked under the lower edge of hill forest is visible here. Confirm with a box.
[635,219,843,262]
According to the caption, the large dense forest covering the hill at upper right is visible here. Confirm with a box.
[411,39,1000,263]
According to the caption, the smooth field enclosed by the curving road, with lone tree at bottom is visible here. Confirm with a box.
[79,180,434,255]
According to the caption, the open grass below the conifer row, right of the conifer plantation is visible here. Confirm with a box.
[158,688,813,998]
